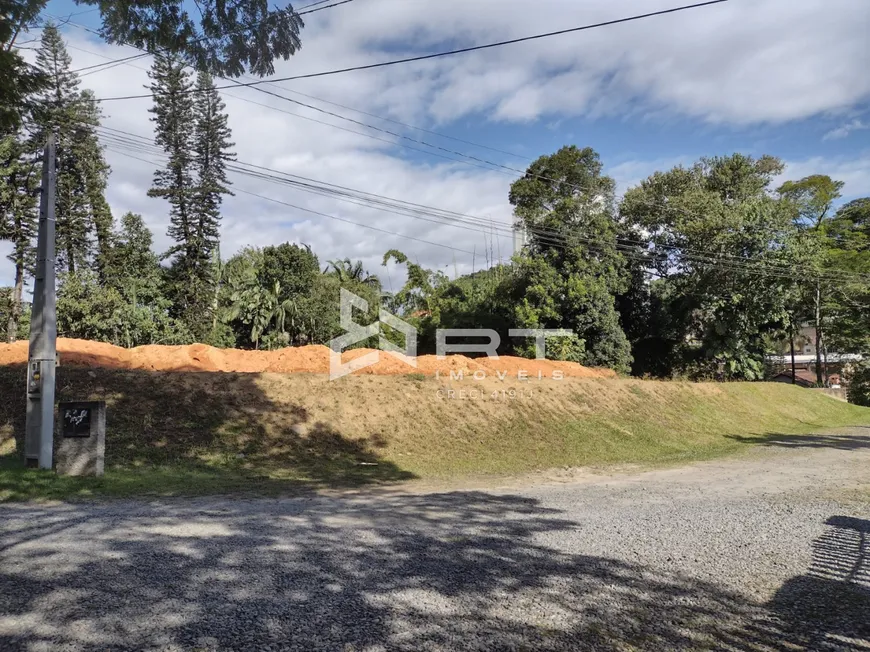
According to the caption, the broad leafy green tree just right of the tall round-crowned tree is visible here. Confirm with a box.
[620,154,801,380]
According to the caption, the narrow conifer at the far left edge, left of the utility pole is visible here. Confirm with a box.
[0,136,39,342]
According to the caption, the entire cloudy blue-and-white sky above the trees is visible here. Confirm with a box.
[0,0,870,289]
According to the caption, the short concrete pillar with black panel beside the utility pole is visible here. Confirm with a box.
[55,401,106,475]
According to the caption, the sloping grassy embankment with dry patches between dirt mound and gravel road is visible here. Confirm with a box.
[0,366,870,501]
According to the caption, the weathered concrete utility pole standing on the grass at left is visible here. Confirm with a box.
[24,134,57,469]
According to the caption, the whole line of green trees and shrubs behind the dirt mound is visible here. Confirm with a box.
[0,26,870,381]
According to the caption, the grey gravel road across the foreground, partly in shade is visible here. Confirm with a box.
[0,428,870,652]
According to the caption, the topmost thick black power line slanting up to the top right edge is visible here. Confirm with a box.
[78,0,730,102]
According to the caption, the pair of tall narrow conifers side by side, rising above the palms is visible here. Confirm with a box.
[149,55,232,340]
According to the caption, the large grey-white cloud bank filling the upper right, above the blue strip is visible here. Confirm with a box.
[290,0,870,124]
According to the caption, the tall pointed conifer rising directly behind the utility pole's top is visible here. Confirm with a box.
[31,24,111,273]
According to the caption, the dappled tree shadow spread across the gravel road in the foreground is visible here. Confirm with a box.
[0,492,870,651]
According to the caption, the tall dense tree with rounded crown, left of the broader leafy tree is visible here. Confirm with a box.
[510,146,631,371]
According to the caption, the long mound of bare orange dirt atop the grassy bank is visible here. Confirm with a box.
[0,338,616,378]
